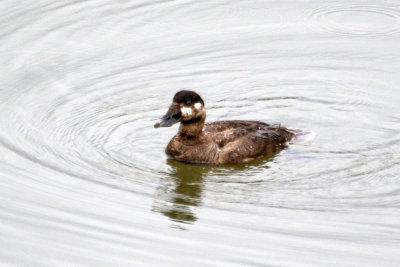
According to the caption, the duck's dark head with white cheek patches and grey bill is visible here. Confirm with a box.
[154,90,206,128]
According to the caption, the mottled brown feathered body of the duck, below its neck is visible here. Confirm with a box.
[167,120,295,164]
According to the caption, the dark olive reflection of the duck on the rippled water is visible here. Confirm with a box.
[152,155,274,229]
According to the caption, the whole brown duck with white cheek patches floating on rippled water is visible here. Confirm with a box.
[154,90,299,164]
